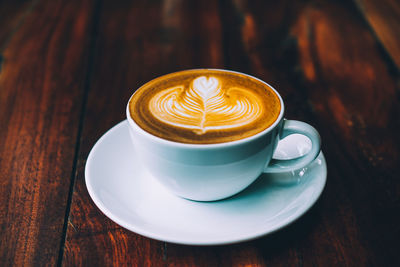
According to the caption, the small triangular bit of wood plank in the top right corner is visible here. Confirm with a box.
[355,0,400,69]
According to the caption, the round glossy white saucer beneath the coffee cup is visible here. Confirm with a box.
[85,121,327,245]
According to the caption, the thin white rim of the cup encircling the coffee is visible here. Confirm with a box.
[126,68,285,149]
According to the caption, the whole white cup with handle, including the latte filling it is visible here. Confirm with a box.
[126,69,320,201]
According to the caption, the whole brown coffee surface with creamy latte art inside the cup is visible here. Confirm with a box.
[129,69,281,144]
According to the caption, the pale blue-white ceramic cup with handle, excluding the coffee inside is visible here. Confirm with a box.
[126,71,321,201]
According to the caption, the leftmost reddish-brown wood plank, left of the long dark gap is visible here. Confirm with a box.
[0,0,97,266]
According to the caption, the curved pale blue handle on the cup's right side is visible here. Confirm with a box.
[264,120,321,173]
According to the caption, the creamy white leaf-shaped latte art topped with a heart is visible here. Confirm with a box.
[149,76,263,135]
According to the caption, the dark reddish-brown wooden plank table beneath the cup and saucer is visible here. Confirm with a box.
[0,0,400,266]
